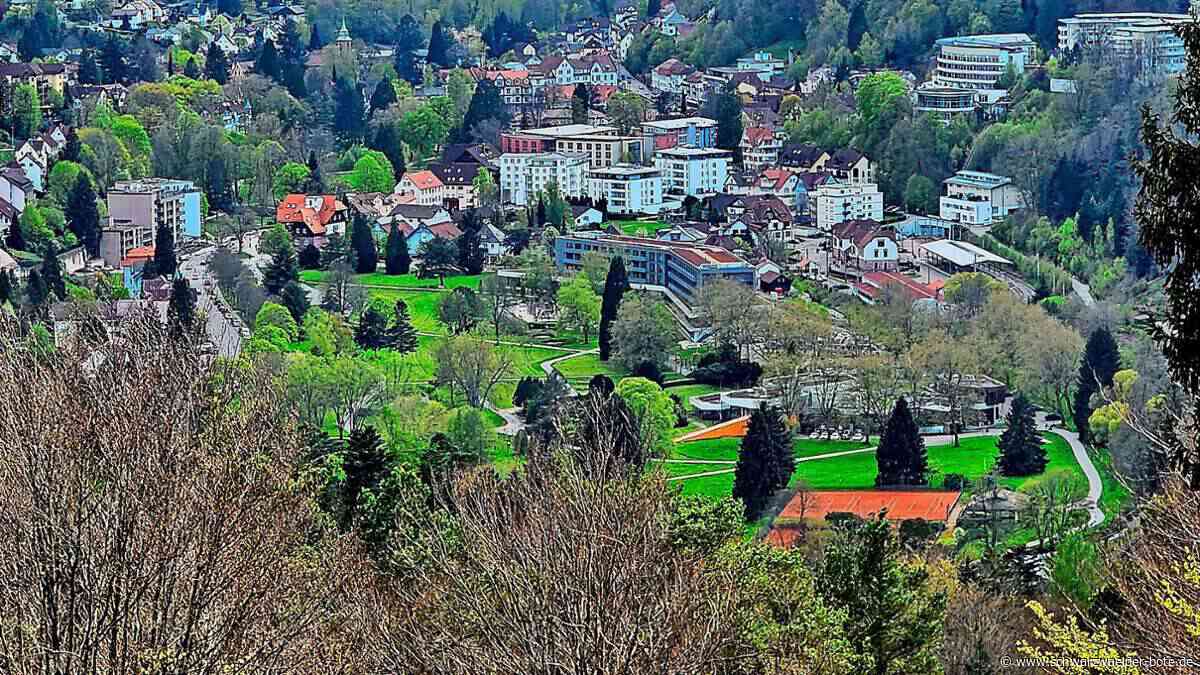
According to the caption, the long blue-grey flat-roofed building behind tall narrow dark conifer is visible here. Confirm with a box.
[554,232,755,309]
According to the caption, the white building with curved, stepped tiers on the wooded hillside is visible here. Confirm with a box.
[917,32,1036,117]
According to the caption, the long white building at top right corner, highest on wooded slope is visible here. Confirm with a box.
[1058,12,1189,78]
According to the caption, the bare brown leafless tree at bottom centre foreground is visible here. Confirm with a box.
[364,461,738,674]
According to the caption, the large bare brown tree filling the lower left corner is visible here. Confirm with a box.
[0,321,364,674]
